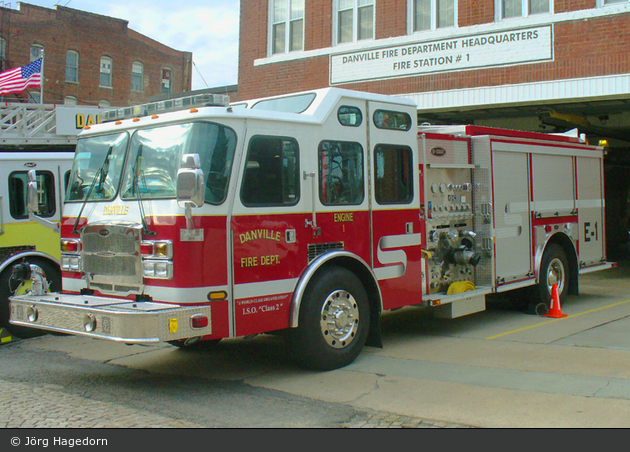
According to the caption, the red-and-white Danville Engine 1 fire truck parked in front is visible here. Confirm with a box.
[11,88,613,370]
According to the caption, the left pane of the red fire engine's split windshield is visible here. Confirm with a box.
[66,133,128,201]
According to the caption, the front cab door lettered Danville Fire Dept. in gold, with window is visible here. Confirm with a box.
[230,129,311,336]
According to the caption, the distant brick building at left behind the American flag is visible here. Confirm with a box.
[0,3,192,107]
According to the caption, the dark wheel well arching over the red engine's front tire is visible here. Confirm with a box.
[298,255,382,348]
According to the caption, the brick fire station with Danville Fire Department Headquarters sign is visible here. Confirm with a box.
[239,0,630,251]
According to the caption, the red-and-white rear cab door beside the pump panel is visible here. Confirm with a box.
[369,102,422,309]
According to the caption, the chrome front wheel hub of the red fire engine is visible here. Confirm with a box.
[320,290,359,348]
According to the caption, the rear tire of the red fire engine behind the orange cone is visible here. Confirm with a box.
[535,243,569,308]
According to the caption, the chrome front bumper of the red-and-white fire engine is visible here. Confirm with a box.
[10,293,212,344]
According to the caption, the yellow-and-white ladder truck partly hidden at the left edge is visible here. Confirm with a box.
[0,103,99,343]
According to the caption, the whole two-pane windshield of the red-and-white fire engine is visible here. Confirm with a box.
[66,122,236,204]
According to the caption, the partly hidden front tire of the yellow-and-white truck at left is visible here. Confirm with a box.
[0,258,61,339]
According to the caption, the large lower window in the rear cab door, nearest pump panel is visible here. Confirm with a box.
[374,144,413,204]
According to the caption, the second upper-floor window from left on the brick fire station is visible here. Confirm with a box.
[336,0,375,44]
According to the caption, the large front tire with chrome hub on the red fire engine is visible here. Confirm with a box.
[289,267,370,370]
